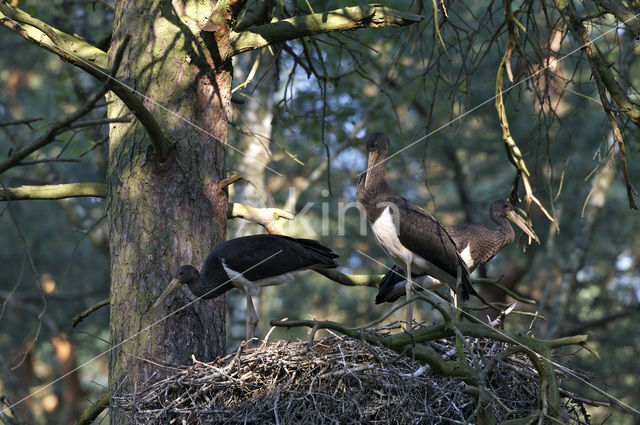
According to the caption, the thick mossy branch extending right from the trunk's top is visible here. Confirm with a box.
[225,4,423,60]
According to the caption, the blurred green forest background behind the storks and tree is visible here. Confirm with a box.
[0,0,640,424]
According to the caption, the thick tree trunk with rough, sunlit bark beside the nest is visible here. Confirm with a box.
[107,0,231,424]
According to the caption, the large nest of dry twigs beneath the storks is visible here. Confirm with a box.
[112,336,588,424]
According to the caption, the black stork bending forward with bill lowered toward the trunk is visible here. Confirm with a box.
[153,235,338,341]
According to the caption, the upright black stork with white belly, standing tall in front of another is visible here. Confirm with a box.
[356,133,476,330]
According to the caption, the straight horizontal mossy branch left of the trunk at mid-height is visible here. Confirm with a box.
[0,183,107,201]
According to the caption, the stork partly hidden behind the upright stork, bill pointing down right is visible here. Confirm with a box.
[376,199,538,304]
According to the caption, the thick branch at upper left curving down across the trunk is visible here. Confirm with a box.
[0,1,171,162]
